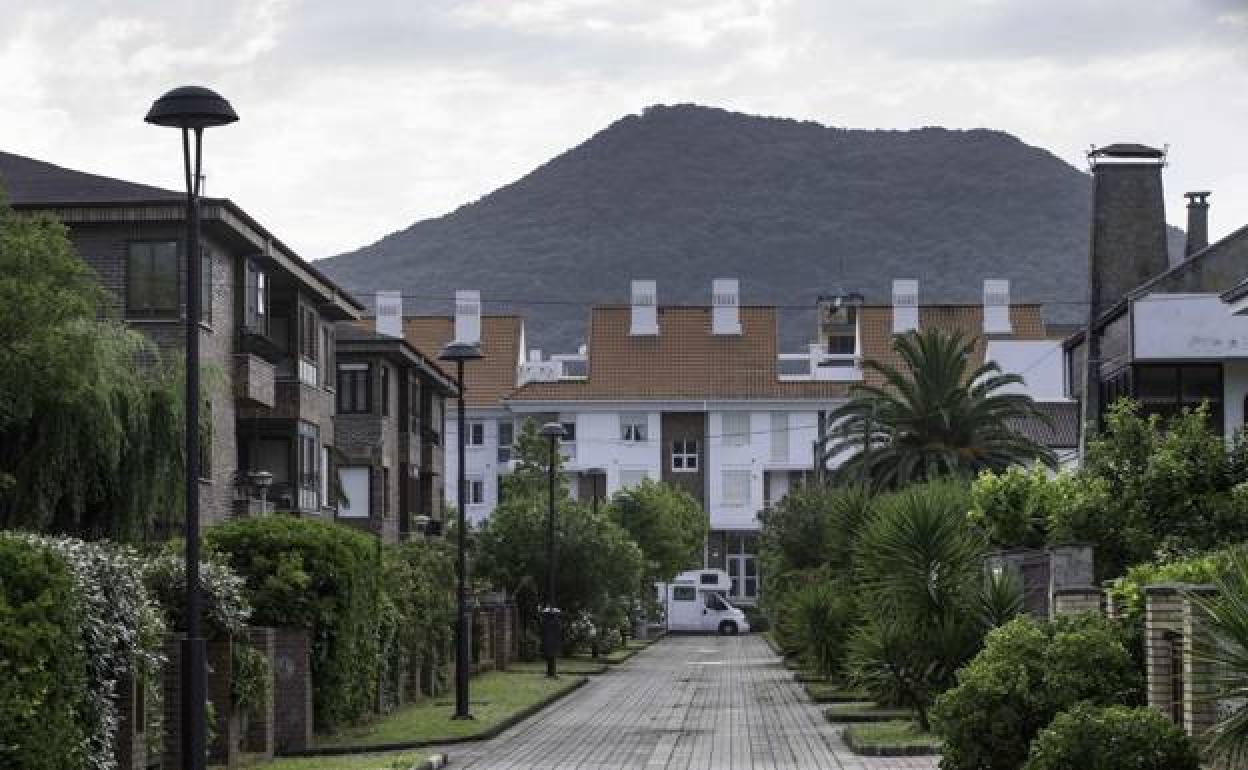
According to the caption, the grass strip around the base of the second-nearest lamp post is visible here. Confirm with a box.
[312,671,582,748]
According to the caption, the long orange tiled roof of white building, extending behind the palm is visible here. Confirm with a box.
[508,305,1045,401]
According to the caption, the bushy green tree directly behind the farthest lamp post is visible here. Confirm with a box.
[478,419,641,643]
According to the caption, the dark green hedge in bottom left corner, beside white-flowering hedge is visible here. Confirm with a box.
[0,538,89,770]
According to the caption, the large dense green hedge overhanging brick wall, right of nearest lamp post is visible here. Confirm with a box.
[205,515,383,730]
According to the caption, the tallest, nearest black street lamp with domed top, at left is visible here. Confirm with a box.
[144,86,238,770]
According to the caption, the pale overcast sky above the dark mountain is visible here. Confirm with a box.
[0,0,1248,258]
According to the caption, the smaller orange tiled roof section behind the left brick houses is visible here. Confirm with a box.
[403,316,524,408]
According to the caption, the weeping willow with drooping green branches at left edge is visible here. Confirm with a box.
[0,192,185,540]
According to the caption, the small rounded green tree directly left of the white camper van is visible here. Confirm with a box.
[608,479,710,584]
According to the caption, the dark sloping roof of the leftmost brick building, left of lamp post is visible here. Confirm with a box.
[0,152,186,206]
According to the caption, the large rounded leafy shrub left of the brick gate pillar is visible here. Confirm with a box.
[932,614,1141,770]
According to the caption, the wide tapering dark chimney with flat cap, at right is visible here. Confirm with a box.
[1088,144,1169,316]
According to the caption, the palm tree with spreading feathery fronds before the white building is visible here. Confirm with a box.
[826,329,1057,487]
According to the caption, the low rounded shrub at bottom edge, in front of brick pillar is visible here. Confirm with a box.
[1023,704,1201,770]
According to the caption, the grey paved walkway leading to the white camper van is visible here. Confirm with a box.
[446,634,936,770]
